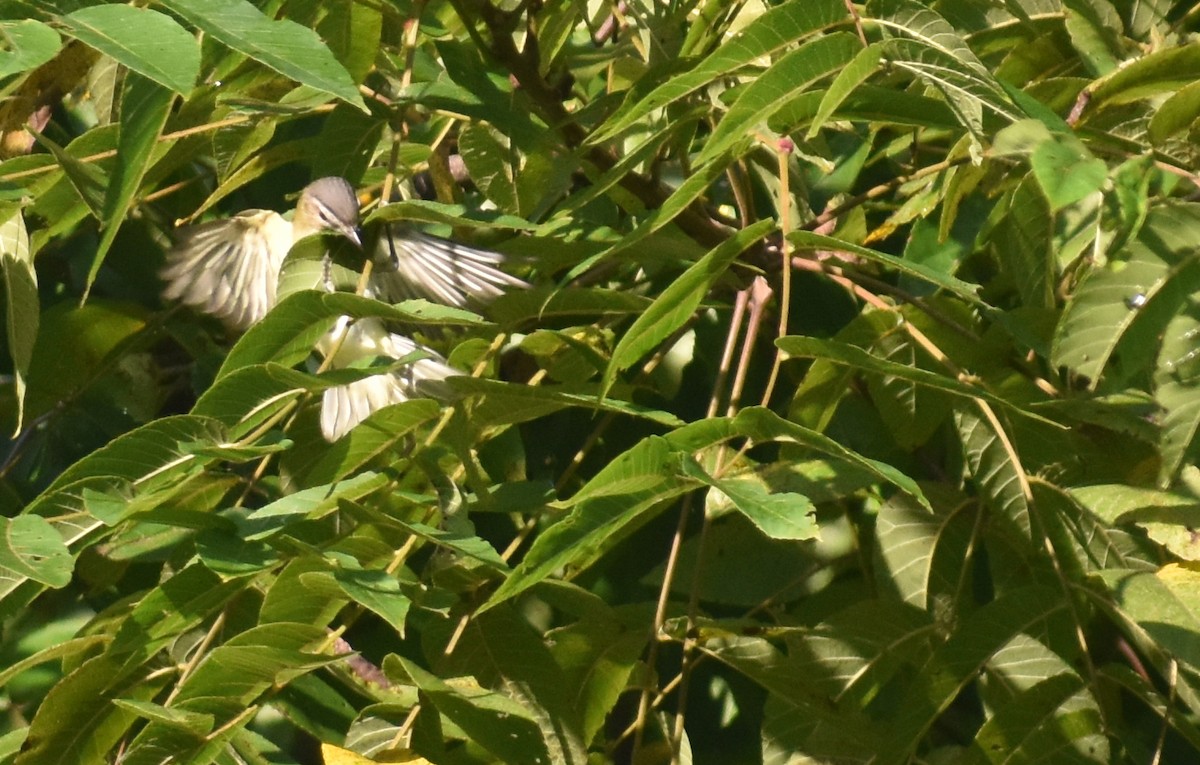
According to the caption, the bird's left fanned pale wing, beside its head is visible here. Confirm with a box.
[158,210,292,331]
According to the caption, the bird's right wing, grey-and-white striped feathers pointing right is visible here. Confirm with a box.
[371,224,529,308]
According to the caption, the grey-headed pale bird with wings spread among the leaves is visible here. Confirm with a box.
[160,176,528,441]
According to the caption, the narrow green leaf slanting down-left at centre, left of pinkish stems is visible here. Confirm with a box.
[600,215,774,397]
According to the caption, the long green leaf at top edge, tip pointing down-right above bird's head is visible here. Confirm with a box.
[163,0,366,110]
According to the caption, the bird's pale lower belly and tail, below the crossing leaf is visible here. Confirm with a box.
[317,317,462,441]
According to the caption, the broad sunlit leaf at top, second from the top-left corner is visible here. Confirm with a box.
[59,5,200,96]
